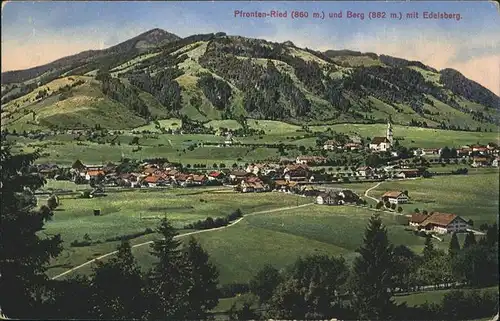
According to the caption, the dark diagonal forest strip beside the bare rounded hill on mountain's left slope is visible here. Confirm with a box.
[96,73,151,119]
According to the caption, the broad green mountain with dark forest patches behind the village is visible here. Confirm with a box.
[2,29,500,130]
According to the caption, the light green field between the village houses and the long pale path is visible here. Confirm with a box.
[44,188,310,275]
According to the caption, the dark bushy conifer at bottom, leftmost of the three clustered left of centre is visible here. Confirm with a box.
[91,241,145,319]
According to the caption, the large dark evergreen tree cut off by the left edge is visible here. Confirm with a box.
[0,146,62,319]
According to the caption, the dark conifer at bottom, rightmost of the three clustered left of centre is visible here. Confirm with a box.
[184,237,219,320]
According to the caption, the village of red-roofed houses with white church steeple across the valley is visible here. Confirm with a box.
[32,123,499,241]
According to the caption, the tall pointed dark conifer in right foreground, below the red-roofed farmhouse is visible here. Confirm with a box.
[352,214,394,320]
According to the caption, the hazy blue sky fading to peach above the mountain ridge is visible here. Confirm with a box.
[2,1,500,95]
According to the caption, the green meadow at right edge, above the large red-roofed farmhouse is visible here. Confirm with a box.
[370,169,499,224]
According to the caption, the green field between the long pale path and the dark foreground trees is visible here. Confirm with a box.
[123,205,436,284]
